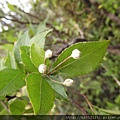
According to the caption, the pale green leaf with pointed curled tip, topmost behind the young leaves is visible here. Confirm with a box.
[29,29,52,48]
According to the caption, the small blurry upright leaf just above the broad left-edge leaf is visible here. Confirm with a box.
[5,51,16,69]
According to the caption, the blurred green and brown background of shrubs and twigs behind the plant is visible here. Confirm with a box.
[0,0,120,115]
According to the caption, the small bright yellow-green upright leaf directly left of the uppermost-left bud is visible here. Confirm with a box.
[30,44,45,67]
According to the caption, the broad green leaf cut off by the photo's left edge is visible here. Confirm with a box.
[0,68,25,96]
